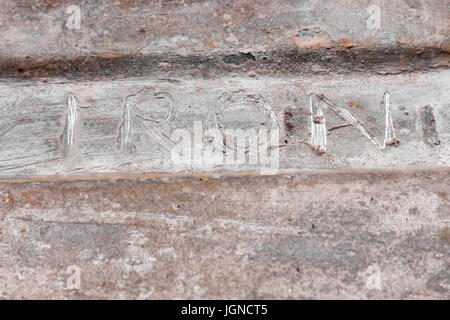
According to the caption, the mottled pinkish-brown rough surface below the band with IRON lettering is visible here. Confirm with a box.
[0,169,450,299]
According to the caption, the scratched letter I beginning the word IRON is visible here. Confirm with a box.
[60,94,79,158]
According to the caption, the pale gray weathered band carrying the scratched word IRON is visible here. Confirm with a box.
[0,70,450,178]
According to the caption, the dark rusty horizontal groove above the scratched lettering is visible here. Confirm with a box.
[0,47,450,81]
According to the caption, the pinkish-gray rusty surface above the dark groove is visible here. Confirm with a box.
[0,0,449,59]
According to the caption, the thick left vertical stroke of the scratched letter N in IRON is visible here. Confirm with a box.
[309,95,327,153]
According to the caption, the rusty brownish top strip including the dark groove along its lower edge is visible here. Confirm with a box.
[0,0,450,79]
